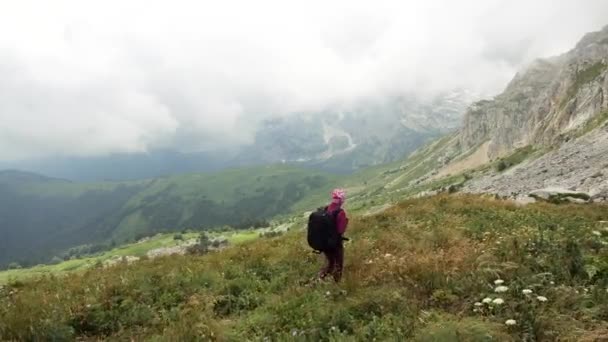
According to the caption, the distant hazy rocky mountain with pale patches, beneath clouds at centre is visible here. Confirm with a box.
[237,90,475,172]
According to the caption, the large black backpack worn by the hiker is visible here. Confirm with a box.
[308,207,342,252]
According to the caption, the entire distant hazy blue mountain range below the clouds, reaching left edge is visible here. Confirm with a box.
[0,90,477,182]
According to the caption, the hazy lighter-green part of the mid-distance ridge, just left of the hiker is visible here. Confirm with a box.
[109,165,336,240]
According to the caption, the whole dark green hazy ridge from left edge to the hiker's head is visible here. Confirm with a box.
[0,166,333,266]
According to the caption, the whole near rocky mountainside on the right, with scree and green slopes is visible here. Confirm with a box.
[366,27,608,201]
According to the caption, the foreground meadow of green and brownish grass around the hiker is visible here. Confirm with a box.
[0,195,608,341]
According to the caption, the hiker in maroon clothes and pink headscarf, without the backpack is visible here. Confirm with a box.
[319,189,348,282]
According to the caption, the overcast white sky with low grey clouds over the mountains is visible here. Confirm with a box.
[0,0,608,160]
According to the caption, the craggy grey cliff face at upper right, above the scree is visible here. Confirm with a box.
[459,26,608,159]
